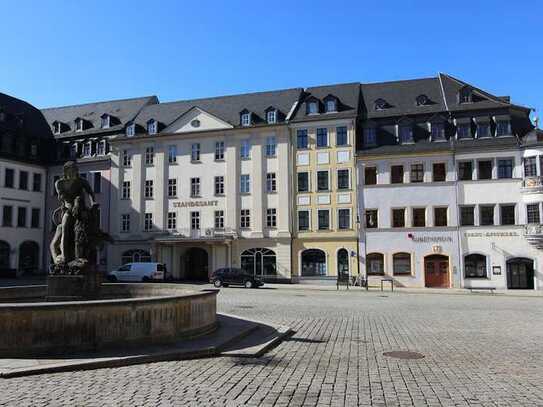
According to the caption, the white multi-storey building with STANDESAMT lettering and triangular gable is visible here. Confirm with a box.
[110,89,301,280]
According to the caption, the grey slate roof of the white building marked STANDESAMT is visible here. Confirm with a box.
[134,88,302,131]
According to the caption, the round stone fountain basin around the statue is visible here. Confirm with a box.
[0,284,218,357]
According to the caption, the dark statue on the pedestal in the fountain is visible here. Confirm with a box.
[50,161,110,274]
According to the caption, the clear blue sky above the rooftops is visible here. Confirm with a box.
[0,0,543,121]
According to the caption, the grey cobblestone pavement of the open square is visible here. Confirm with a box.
[0,288,543,406]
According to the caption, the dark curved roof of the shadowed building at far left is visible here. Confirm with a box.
[0,93,52,139]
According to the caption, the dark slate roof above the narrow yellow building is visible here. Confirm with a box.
[291,82,360,122]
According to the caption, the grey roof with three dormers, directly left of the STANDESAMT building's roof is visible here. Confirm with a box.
[42,96,158,138]
